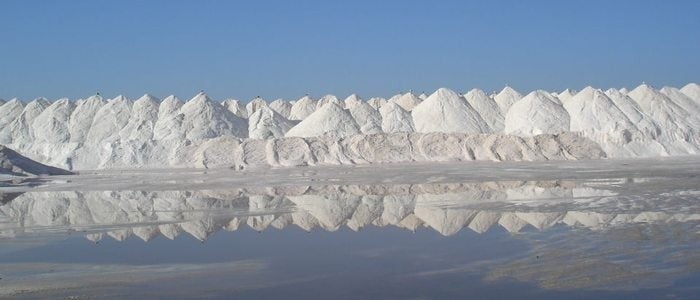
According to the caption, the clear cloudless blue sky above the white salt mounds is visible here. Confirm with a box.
[0,0,700,101]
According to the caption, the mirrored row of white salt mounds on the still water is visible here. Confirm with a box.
[0,179,700,241]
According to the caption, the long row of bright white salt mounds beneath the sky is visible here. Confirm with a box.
[0,83,700,167]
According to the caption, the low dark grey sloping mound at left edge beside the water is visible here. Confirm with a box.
[0,145,72,176]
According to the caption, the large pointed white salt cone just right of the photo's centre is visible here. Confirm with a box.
[411,88,490,133]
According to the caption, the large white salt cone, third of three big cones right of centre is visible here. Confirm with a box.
[564,87,636,134]
